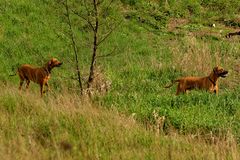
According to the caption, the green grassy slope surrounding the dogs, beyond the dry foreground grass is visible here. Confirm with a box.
[0,0,240,158]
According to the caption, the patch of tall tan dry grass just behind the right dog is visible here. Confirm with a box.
[172,36,221,74]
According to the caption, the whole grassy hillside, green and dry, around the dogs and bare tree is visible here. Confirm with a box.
[0,0,240,159]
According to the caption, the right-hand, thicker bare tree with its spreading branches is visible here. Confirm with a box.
[72,0,121,88]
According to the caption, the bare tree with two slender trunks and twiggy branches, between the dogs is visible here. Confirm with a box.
[56,0,121,93]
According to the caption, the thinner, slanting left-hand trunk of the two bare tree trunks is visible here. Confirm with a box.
[65,0,83,95]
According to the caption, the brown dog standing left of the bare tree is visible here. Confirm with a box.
[17,58,62,96]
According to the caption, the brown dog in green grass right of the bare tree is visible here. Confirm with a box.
[165,66,228,95]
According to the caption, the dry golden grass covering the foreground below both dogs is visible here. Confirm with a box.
[0,85,239,160]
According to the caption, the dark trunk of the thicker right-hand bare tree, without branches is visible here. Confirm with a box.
[87,0,99,88]
